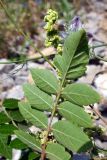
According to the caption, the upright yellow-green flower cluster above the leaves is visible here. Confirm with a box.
[44,9,62,53]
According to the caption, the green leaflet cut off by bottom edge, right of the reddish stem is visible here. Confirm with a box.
[46,143,71,160]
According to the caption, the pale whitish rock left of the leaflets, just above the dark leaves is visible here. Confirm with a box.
[6,85,24,100]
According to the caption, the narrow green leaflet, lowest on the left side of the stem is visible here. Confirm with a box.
[15,130,41,152]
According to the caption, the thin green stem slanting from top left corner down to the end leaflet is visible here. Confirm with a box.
[0,0,55,68]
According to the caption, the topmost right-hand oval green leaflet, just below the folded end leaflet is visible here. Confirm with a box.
[62,83,100,106]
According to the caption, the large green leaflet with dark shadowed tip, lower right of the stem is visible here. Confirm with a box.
[53,120,92,152]
